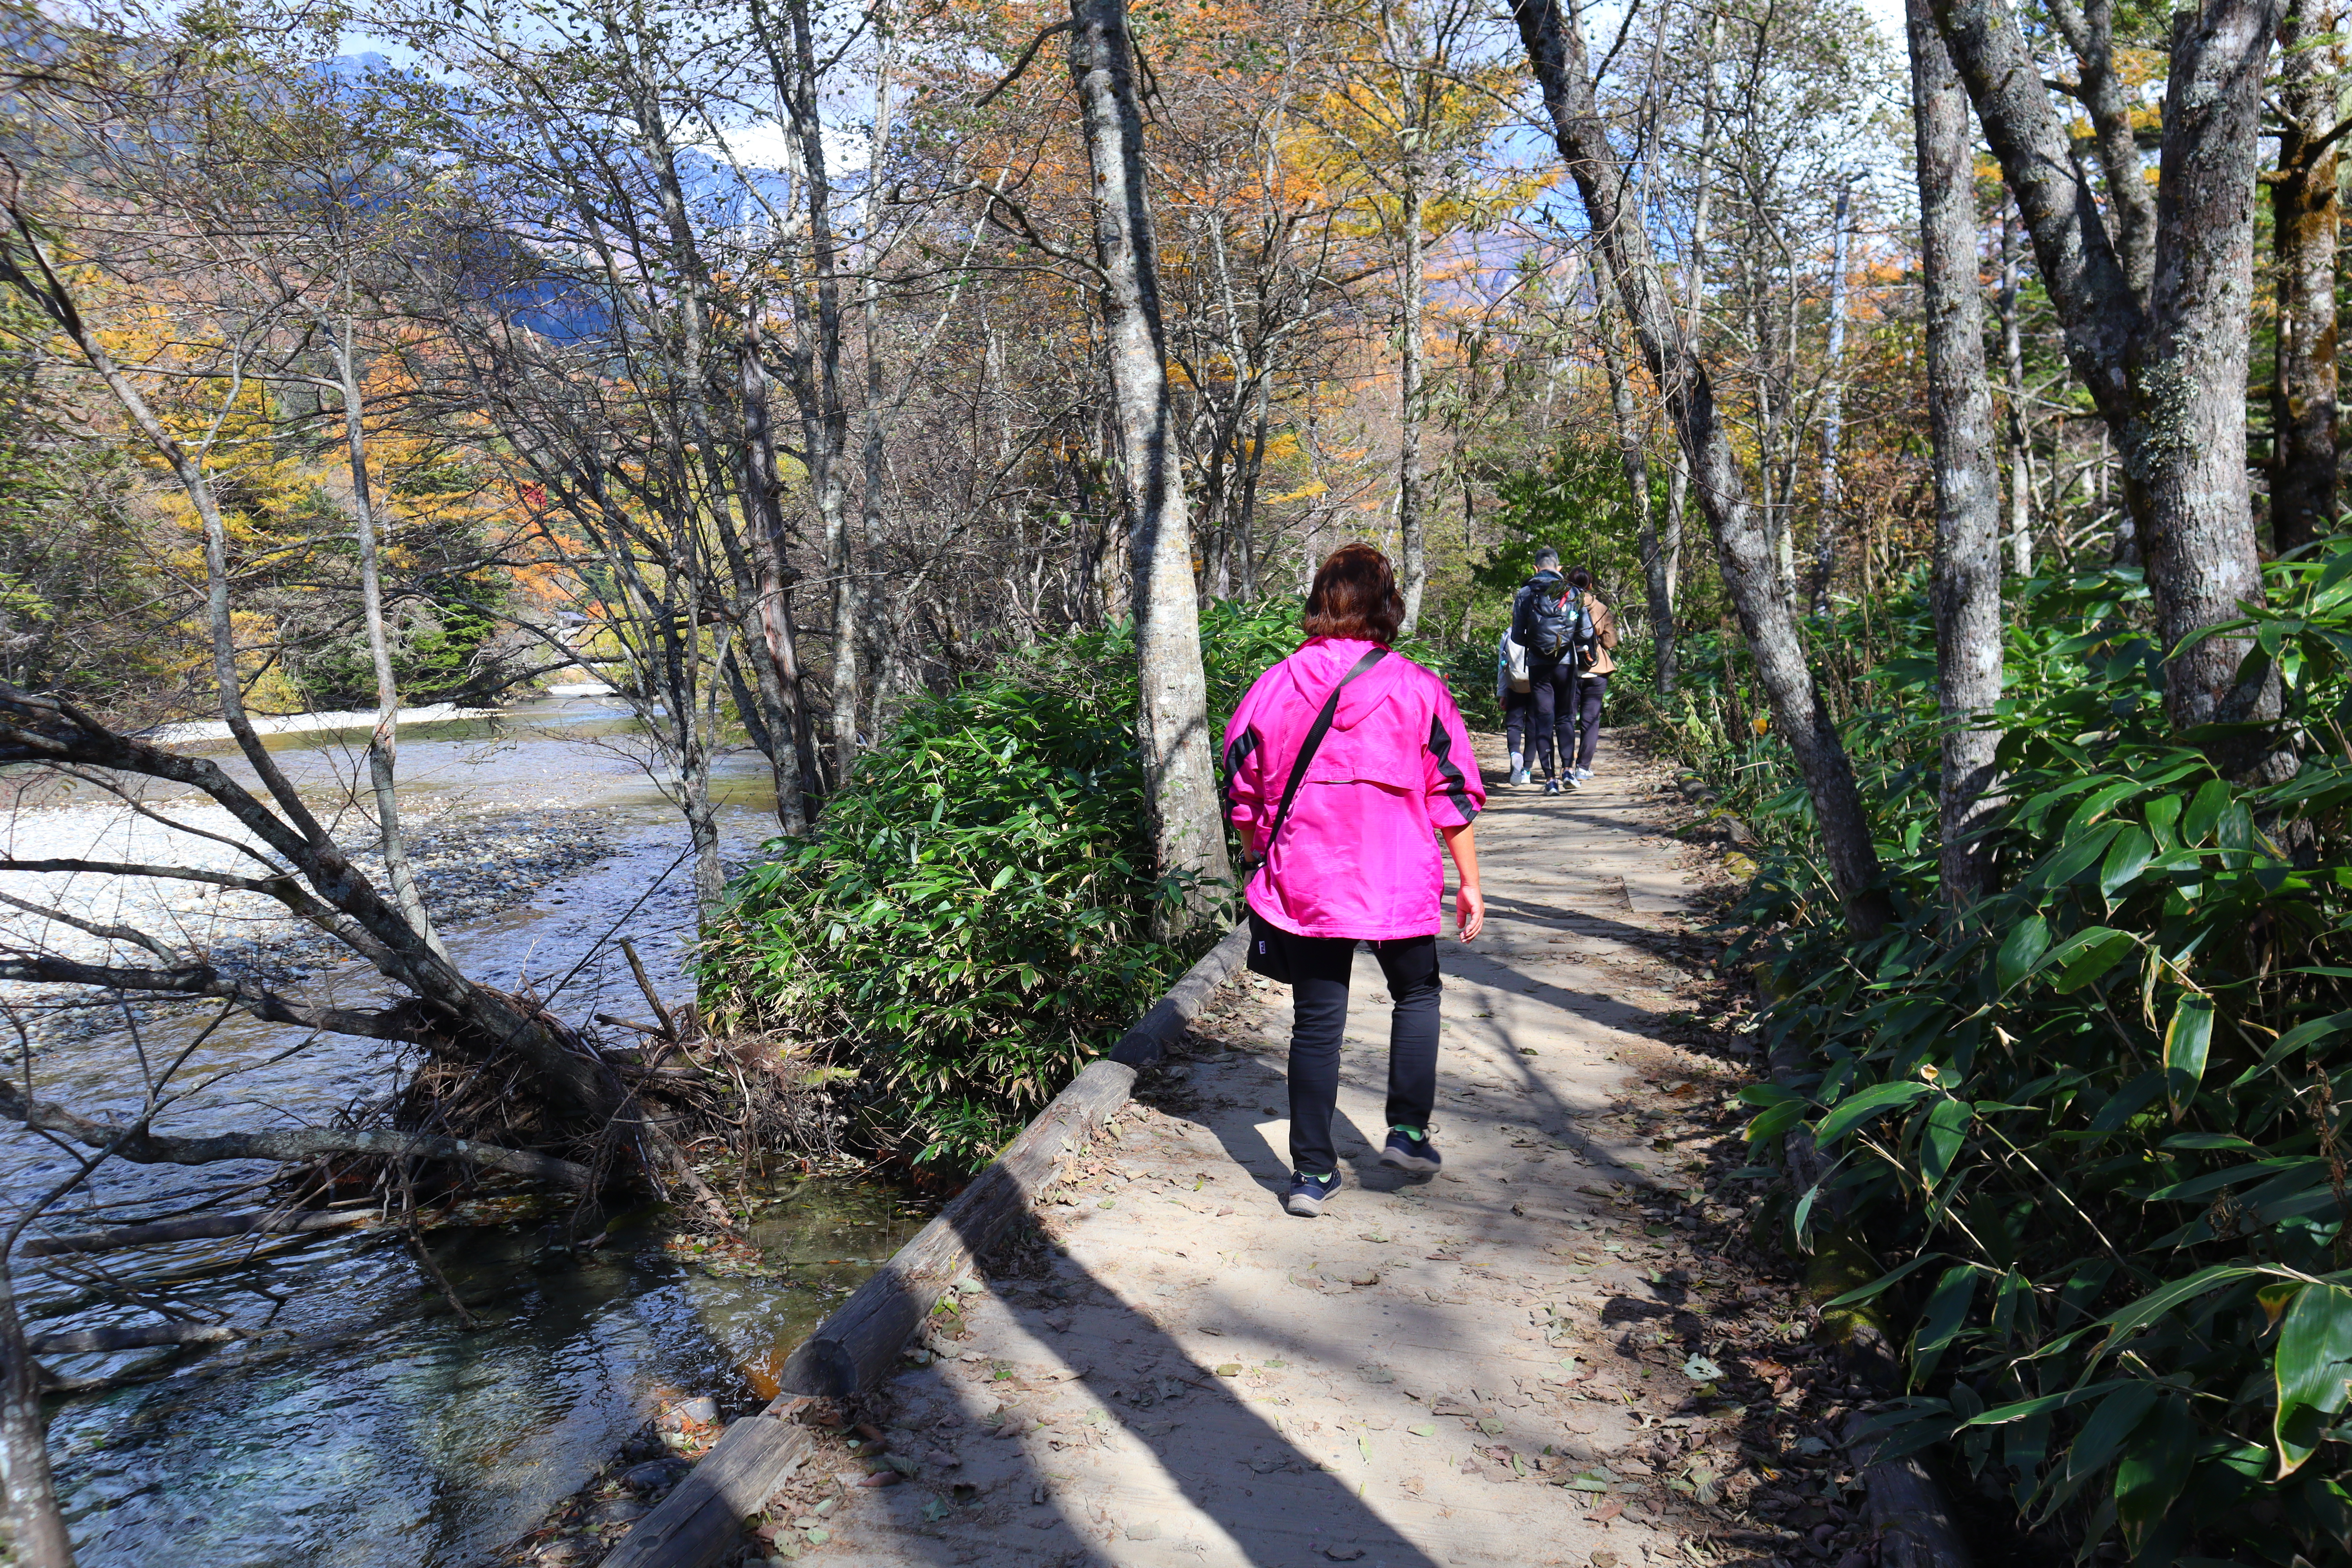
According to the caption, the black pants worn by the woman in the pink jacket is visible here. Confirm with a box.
[1282,933,1442,1176]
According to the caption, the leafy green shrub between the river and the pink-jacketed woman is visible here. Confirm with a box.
[703,599,1298,1169]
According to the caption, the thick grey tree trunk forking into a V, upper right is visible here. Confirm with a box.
[1936,0,2281,752]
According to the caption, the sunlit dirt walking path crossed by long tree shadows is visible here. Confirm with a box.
[724,738,1870,1568]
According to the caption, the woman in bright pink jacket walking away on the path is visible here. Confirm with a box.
[1225,545,1486,1215]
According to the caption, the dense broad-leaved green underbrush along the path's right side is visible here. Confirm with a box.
[1651,548,2352,1566]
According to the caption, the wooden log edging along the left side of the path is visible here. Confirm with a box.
[604,922,1249,1568]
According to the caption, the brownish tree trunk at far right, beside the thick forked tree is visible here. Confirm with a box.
[2265,0,2343,555]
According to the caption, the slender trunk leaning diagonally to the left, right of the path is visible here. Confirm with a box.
[1512,0,1886,938]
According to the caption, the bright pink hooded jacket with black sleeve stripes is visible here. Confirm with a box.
[1225,637,1486,940]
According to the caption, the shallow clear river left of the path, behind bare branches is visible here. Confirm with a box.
[0,698,922,1568]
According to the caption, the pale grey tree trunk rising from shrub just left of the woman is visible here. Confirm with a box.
[1070,0,1232,936]
